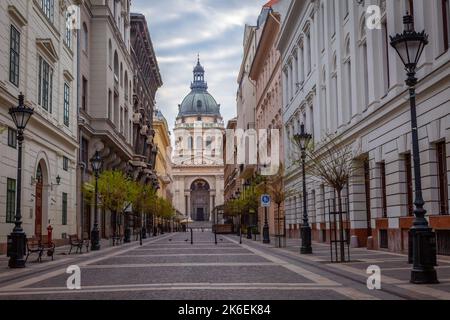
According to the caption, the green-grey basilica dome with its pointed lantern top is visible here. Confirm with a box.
[177,59,222,118]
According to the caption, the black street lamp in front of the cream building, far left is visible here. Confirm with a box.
[7,93,33,268]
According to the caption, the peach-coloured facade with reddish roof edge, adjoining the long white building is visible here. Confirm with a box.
[249,3,284,235]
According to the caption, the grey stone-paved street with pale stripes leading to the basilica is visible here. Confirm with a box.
[0,231,449,300]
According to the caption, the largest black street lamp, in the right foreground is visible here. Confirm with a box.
[390,13,438,284]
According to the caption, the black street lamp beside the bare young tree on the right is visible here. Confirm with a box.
[294,123,312,254]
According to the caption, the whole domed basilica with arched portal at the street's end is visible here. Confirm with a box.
[172,59,224,221]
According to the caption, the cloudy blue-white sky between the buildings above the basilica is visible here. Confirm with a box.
[132,0,268,134]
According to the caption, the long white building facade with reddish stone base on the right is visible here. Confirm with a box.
[278,0,450,255]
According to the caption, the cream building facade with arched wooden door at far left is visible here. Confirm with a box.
[0,0,78,252]
